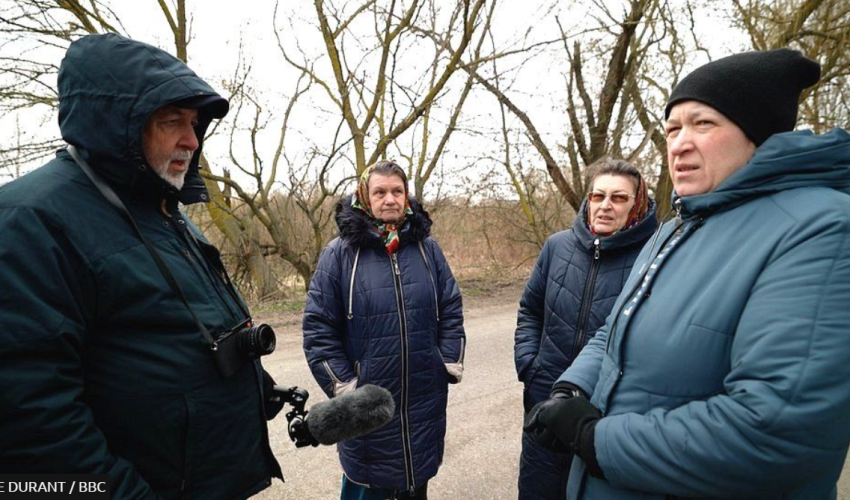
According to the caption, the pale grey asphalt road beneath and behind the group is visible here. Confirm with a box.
[255,301,850,500]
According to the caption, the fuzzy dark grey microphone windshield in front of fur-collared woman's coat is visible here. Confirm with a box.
[306,384,395,444]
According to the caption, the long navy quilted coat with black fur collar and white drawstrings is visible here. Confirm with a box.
[303,197,465,490]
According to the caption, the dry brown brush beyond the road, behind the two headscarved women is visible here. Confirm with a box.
[185,191,573,308]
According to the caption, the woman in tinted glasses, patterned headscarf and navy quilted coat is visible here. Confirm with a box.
[514,160,658,499]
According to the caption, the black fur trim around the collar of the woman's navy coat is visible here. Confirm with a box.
[336,195,431,248]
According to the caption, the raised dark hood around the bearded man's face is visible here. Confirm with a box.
[59,34,227,204]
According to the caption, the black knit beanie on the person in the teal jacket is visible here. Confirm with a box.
[664,49,820,146]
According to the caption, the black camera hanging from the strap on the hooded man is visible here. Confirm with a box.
[213,318,277,378]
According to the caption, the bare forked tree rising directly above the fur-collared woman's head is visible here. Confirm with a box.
[281,0,484,188]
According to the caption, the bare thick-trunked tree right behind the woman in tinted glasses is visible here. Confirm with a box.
[430,0,684,219]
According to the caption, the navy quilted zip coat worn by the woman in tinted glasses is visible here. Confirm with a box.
[514,201,658,411]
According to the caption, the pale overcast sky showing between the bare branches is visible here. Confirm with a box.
[0,0,743,197]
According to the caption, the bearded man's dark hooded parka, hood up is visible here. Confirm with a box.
[0,35,280,499]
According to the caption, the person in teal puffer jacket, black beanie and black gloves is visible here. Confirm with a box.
[527,49,850,500]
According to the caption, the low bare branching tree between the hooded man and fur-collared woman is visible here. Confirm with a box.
[205,67,350,292]
